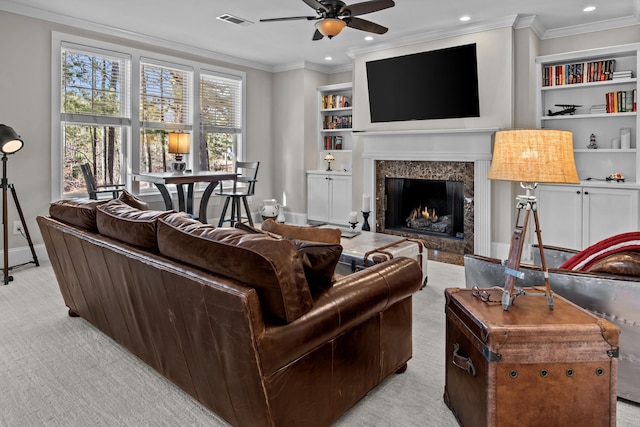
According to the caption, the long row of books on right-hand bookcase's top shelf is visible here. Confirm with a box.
[542,59,616,86]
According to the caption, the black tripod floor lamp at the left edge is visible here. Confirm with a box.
[0,125,40,285]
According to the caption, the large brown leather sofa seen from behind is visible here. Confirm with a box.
[37,201,421,427]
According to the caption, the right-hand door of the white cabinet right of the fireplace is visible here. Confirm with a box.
[582,187,638,249]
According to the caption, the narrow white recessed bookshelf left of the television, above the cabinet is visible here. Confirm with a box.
[317,83,353,170]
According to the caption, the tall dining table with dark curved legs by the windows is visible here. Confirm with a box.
[132,171,238,224]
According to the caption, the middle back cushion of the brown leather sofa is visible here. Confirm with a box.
[96,199,173,251]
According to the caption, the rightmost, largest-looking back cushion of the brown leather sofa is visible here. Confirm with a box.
[158,214,313,322]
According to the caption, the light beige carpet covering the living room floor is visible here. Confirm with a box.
[0,261,640,427]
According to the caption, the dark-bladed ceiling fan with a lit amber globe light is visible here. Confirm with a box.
[260,0,395,40]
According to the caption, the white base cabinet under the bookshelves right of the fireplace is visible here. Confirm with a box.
[536,185,640,250]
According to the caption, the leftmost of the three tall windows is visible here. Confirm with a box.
[60,46,131,195]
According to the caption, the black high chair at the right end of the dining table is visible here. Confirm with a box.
[216,162,260,227]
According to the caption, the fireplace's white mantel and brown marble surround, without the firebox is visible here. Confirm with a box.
[354,129,498,256]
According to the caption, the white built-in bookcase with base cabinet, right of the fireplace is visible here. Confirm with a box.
[536,44,640,249]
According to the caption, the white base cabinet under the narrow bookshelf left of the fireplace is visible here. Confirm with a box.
[307,171,352,226]
